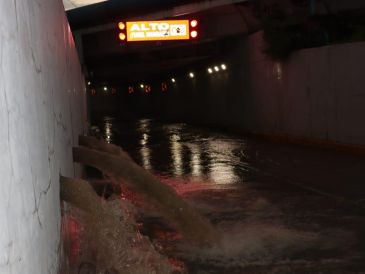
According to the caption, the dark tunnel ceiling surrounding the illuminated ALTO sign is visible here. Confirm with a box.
[67,0,365,85]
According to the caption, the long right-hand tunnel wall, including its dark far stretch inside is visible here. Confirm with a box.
[133,33,365,145]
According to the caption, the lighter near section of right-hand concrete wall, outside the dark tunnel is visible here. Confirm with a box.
[241,33,365,145]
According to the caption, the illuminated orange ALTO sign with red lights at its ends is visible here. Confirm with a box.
[118,20,198,42]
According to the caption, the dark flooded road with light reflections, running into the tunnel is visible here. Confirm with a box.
[93,117,365,274]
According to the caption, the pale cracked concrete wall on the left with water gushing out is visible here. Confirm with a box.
[0,0,86,274]
